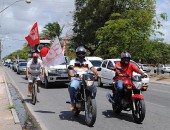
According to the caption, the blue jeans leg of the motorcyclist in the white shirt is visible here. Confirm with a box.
[69,78,81,104]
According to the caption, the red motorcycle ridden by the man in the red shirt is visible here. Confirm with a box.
[106,68,148,123]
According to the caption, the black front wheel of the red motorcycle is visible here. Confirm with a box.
[132,99,146,123]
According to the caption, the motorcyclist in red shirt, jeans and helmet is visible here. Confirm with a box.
[114,51,146,105]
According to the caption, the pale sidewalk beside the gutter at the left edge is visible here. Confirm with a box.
[0,66,22,130]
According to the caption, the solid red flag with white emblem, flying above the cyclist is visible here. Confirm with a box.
[25,22,40,47]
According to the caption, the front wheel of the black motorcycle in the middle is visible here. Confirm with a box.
[85,96,97,127]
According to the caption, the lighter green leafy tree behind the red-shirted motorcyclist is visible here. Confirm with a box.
[96,0,155,60]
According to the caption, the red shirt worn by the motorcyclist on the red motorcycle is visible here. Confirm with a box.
[114,62,139,80]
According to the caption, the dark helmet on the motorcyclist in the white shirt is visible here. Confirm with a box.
[76,46,86,60]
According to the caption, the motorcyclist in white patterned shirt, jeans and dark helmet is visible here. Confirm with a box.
[68,46,100,111]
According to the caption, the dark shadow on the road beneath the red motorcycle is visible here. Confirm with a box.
[102,110,134,122]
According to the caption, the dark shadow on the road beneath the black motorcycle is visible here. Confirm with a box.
[59,111,86,125]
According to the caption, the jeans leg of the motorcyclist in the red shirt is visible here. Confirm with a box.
[114,80,123,104]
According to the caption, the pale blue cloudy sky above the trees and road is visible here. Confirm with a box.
[0,0,170,58]
